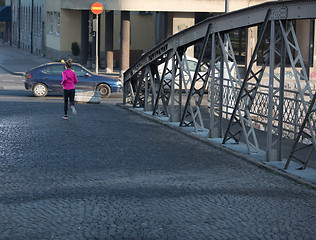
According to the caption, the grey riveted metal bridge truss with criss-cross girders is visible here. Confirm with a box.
[124,0,316,169]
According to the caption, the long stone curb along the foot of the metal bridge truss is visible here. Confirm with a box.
[116,103,316,189]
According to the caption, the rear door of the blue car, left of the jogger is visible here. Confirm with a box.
[42,65,65,92]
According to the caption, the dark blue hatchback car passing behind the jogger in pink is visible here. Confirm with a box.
[24,63,123,97]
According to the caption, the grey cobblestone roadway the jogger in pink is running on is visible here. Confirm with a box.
[0,96,316,240]
